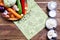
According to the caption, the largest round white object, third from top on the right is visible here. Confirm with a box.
[46,18,57,29]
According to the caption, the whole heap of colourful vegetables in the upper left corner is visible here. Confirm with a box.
[0,0,27,20]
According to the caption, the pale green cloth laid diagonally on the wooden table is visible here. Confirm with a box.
[14,0,48,40]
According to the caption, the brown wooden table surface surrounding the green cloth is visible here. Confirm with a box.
[0,0,60,40]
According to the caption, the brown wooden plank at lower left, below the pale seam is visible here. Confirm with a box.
[0,25,26,39]
